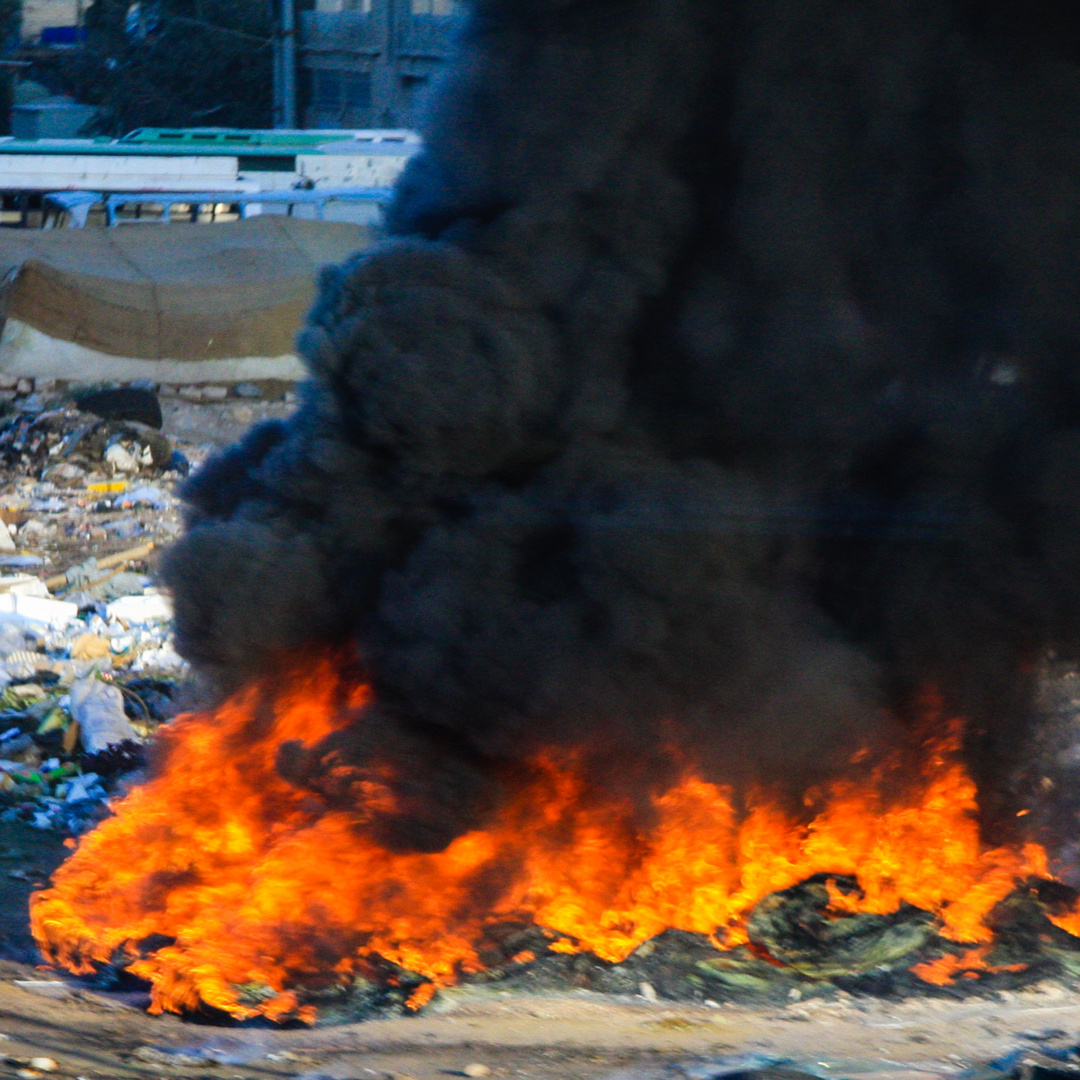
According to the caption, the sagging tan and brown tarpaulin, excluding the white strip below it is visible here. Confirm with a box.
[0,215,370,361]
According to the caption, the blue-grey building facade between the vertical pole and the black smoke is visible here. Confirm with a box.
[298,0,458,127]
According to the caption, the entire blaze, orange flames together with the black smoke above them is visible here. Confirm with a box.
[27,0,1080,1015]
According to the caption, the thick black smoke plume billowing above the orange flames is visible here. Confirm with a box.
[159,0,1080,849]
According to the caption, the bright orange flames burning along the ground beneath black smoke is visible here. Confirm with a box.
[31,658,1075,1020]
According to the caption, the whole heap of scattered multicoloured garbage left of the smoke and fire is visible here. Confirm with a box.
[0,386,201,835]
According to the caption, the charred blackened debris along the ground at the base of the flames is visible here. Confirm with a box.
[204,876,1080,1024]
